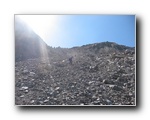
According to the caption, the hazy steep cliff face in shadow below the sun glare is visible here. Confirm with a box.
[15,17,47,62]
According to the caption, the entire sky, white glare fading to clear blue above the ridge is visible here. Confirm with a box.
[19,15,136,48]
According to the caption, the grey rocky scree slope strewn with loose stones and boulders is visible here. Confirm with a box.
[15,42,136,105]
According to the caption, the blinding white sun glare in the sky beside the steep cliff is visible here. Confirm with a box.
[19,15,58,42]
